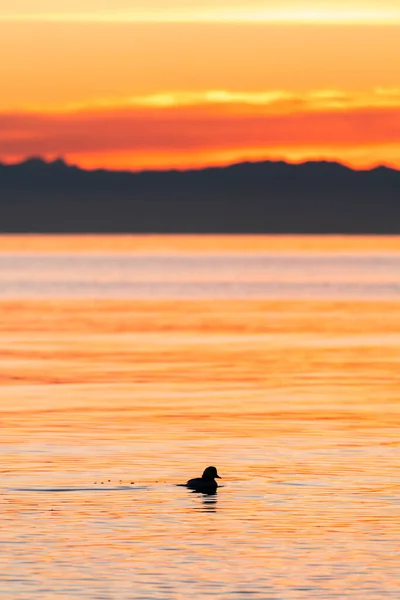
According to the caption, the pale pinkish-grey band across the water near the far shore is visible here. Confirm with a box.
[0,250,400,299]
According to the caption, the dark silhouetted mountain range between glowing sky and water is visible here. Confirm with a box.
[0,158,400,234]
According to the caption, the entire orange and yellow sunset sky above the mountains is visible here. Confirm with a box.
[0,0,400,170]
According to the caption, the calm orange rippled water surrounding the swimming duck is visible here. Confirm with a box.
[0,236,400,600]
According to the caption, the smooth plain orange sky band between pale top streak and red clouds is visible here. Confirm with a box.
[0,23,400,110]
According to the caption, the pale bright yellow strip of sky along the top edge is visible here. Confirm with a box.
[0,0,400,23]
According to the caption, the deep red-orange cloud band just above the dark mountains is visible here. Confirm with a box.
[0,90,400,168]
